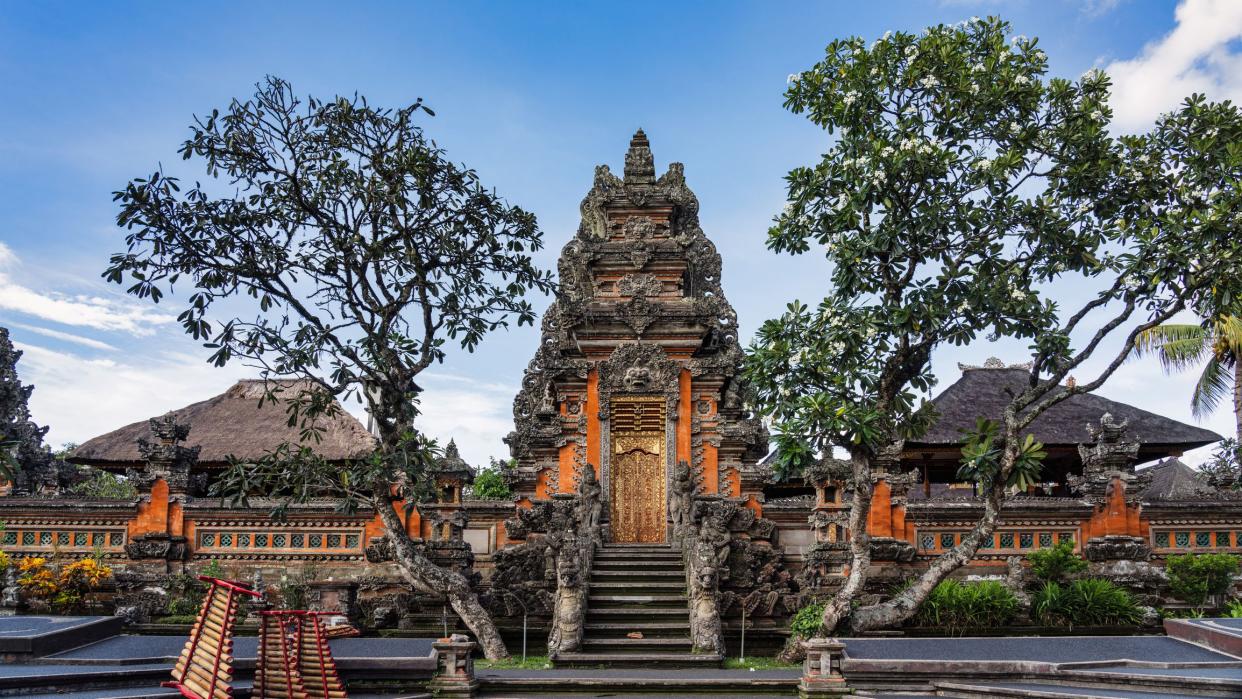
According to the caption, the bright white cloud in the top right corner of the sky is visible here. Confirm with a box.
[1104,0,1242,132]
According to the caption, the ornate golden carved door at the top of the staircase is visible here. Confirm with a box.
[609,396,666,544]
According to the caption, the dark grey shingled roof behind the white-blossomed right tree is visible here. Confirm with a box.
[905,368,1223,453]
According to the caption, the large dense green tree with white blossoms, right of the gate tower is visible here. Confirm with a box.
[748,19,1242,632]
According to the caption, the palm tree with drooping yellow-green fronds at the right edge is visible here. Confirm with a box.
[1134,315,1242,440]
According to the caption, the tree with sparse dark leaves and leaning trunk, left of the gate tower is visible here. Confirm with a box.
[104,77,553,658]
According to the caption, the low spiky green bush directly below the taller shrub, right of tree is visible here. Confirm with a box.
[1031,577,1143,627]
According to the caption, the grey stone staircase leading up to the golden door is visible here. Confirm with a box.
[554,544,723,668]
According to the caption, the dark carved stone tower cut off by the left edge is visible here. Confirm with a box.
[0,328,52,493]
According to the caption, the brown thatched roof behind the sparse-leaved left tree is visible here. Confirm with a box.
[68,380,375,468]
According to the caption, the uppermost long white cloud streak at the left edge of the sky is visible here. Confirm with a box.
[0,243,176,339]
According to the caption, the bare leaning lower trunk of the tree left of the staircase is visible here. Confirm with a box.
[374,493,509,661]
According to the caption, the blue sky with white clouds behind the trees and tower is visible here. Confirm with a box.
[0,0,1242,462]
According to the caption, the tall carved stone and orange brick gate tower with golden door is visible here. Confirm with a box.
[505,130,768,543]
